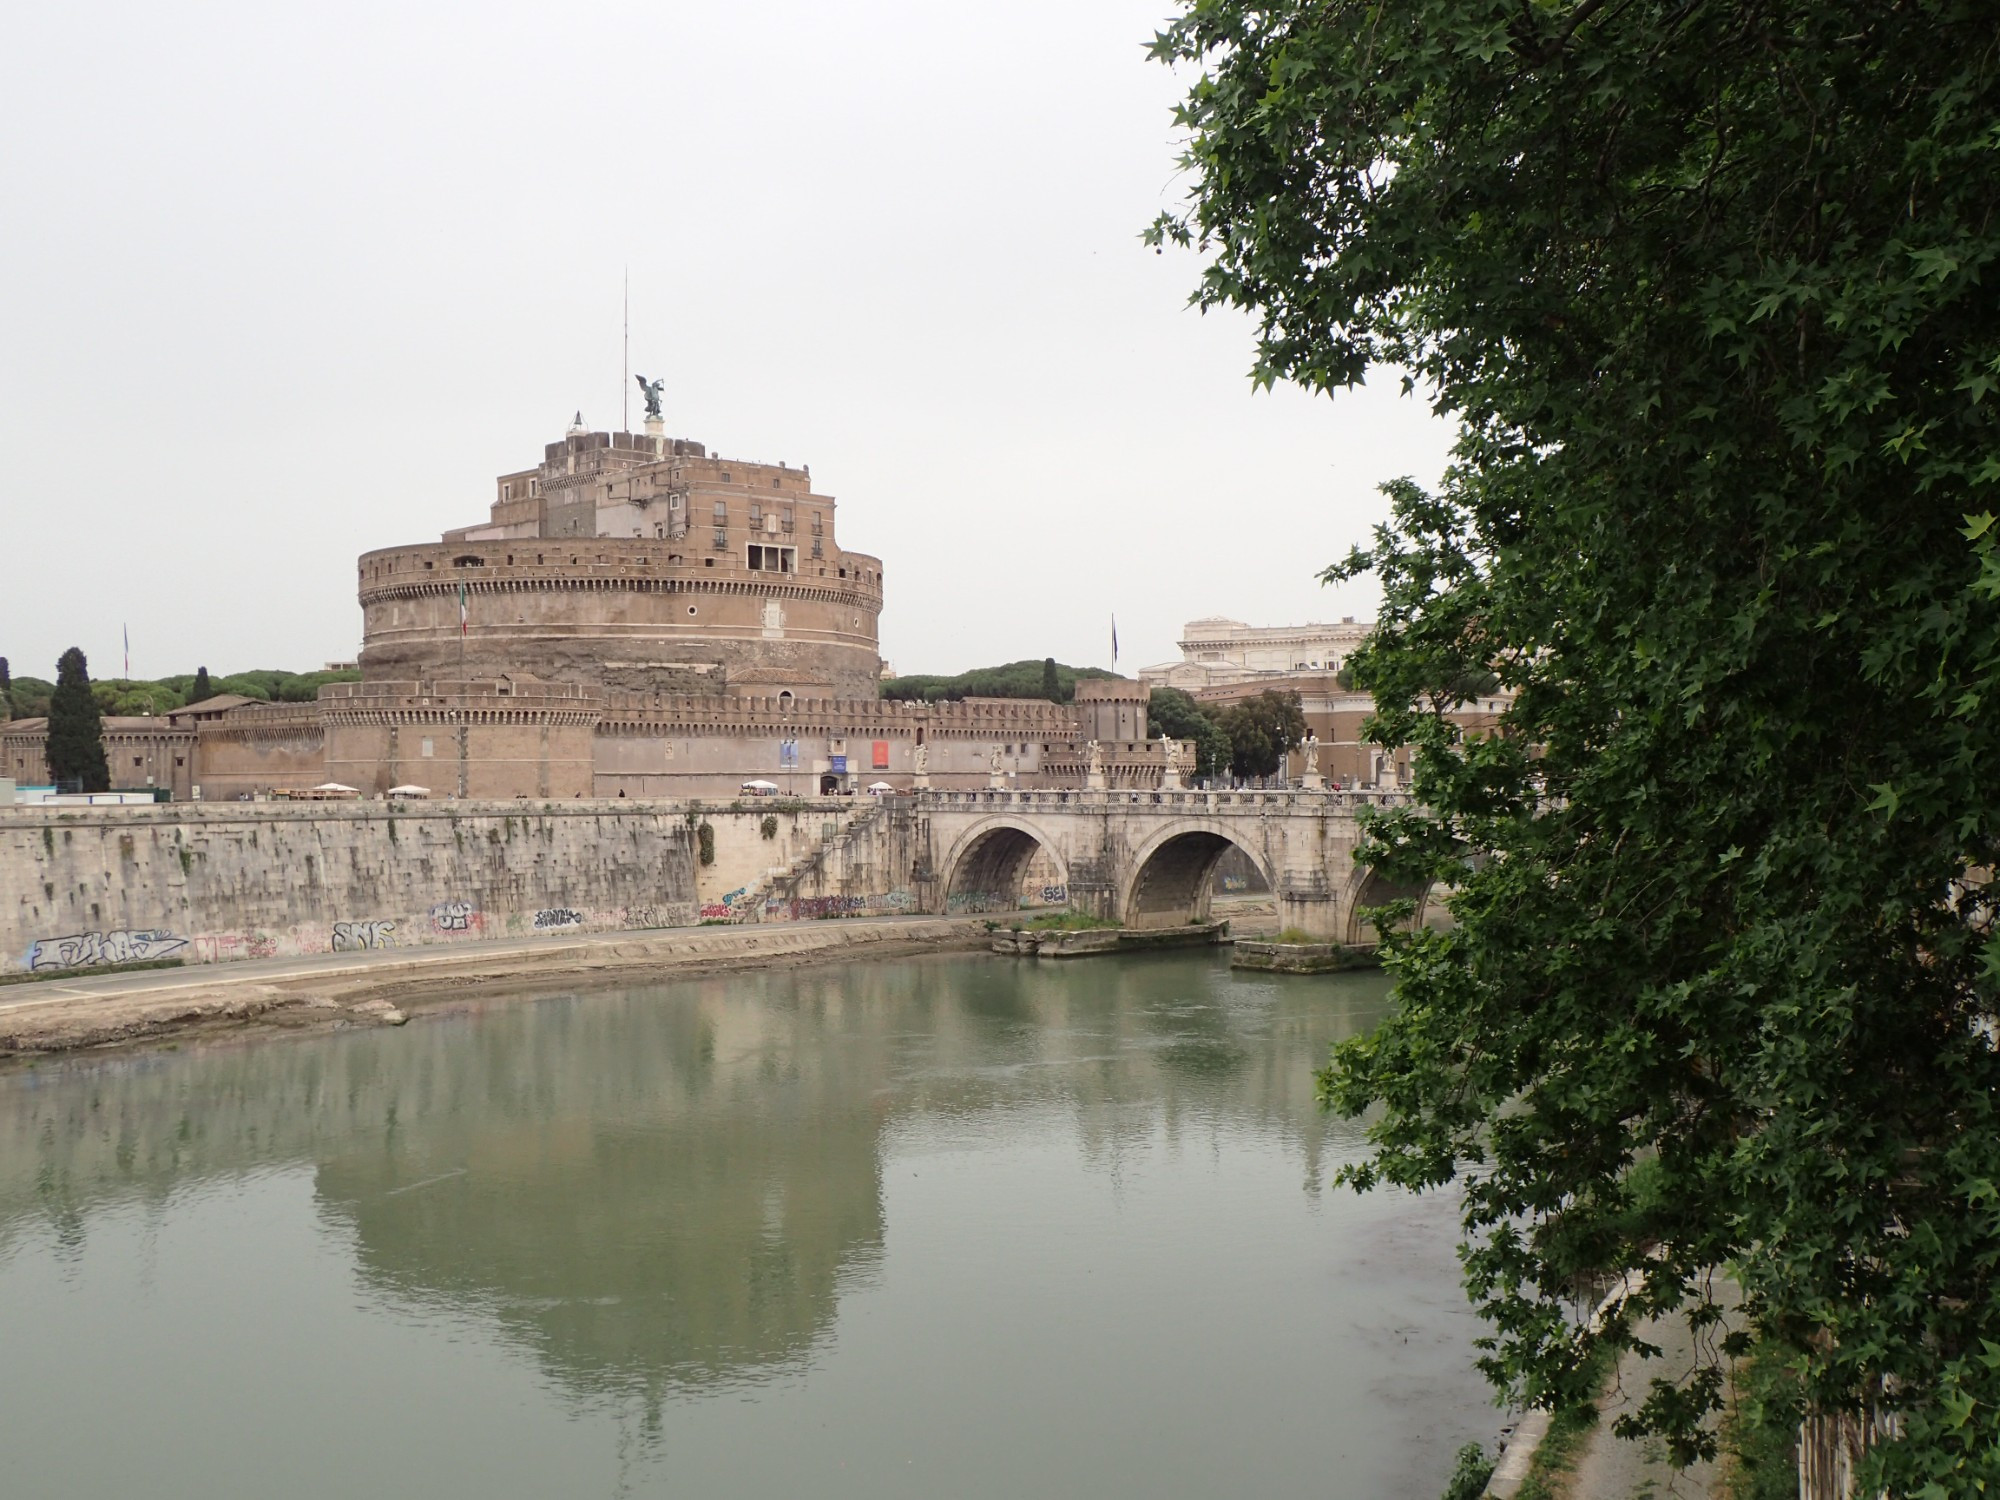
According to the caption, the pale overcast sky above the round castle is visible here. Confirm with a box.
[0,0,1450,676]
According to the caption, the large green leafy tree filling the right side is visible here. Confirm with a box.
[1154,0,2000,1496]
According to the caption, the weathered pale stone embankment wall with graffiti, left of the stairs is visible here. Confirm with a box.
[0,802,698,972]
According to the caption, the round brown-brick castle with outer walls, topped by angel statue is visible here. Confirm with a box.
[0,400,1180,800]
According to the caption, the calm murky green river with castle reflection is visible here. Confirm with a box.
[0,954,1498,1500]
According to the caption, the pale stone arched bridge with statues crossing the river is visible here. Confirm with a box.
[890,790,1428,944]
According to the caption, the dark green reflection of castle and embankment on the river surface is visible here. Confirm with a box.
[0,956,1488,1488]
